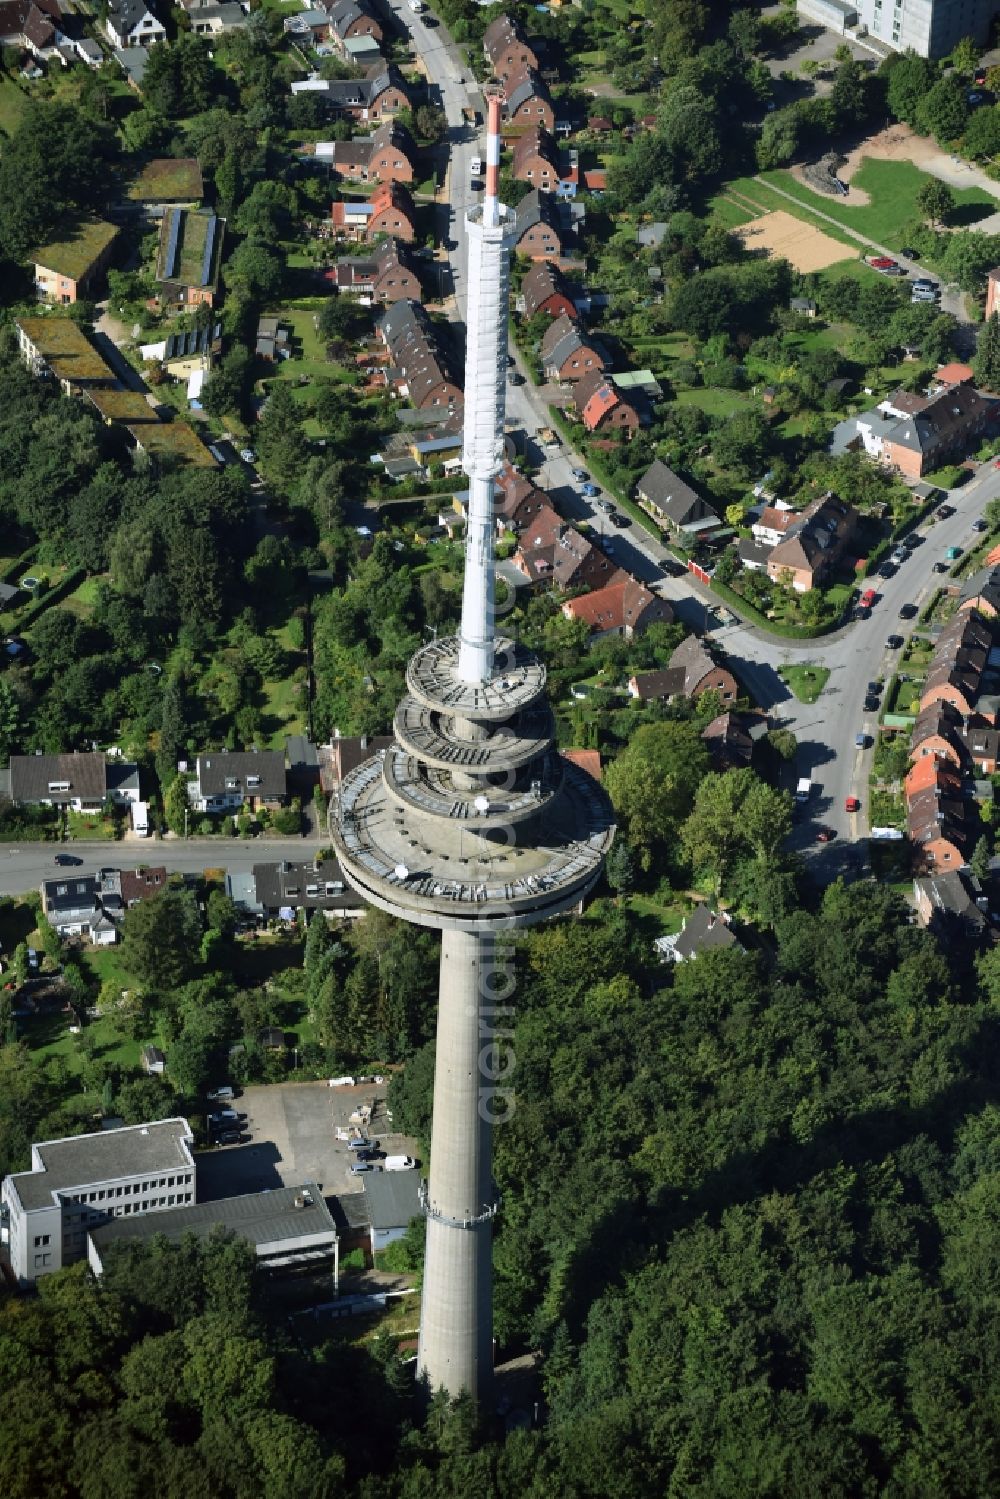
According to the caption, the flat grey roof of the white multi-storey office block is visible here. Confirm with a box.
[9,1118,193,1210]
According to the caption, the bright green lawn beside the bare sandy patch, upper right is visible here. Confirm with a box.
[762,159,1000,249]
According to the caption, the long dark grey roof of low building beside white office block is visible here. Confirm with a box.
[90,1181,337,1253]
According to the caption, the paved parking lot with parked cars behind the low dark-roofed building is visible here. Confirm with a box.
[198,1081,415,1202]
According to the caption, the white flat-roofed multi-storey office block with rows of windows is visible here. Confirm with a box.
[0,1118,196,1286]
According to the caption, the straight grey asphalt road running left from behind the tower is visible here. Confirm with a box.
[0,838,321,896]
